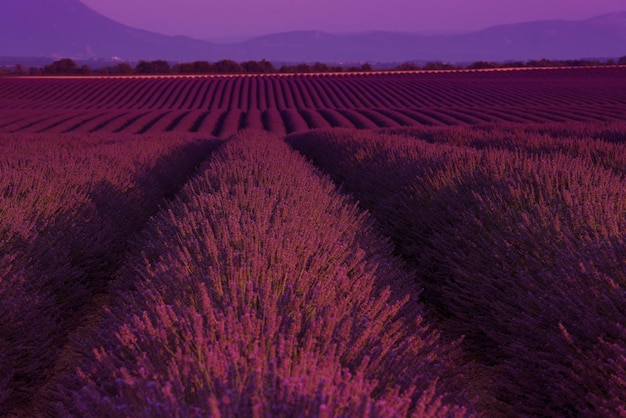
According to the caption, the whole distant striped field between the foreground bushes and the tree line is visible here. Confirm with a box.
[0,68,626,136]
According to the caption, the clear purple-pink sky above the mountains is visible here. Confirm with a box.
[82,0,626,40]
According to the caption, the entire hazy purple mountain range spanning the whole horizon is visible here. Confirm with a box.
[0,0,626,62]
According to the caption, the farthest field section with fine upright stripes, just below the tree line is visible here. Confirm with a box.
[0,68,625,112]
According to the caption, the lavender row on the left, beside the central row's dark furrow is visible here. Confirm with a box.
[0,135,219,414]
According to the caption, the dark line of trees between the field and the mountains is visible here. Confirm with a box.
[0,56,626,75]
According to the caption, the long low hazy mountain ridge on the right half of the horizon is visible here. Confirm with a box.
[239,12,626,62]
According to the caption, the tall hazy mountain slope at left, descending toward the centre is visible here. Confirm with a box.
[0,0,212,60]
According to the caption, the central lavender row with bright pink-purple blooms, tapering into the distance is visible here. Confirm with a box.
[42,131,471,417]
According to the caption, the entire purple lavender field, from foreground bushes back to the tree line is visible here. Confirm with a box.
[0,67,626,417]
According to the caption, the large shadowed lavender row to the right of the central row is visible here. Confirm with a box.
[290,130,626,416]
